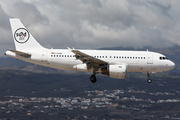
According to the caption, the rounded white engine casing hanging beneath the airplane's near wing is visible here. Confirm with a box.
[109,65,127,79]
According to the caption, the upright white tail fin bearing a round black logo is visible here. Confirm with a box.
[9,19,43,50]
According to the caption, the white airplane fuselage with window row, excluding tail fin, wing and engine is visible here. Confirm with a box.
[5,48,175,73]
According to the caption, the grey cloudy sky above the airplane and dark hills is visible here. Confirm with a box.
[0,0,180,56]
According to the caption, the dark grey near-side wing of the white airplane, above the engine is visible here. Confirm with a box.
[71,50,108,64]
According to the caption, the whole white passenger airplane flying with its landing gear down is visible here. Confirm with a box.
[5,18,175,83]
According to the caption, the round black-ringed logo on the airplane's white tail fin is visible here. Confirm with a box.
[14,28,29,43]
